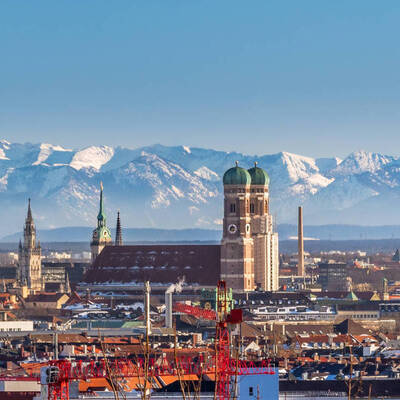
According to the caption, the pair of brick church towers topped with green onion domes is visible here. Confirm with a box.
[221,164,279,292]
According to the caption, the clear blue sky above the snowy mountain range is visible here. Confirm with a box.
[0,0,400,157]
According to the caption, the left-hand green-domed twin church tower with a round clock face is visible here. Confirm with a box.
[221,162,255,292]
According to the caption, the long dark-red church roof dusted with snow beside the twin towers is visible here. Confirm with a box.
[84,244,221,286]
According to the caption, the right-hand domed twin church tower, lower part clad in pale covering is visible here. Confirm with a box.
[248,163,279,291]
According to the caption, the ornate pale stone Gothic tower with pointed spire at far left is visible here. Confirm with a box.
[18,199,42,291]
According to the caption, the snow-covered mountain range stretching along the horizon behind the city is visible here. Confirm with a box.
[0,140,400,239]
